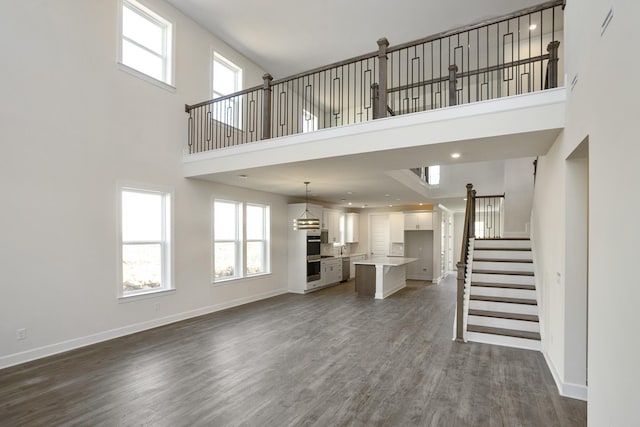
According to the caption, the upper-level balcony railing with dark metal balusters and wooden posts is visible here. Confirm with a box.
[185,0,563,153]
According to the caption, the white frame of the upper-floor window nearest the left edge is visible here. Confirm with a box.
[118,0,175,89]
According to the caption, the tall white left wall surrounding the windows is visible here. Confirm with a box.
[0,0,287,367]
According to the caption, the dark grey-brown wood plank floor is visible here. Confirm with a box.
[0,280,586,427]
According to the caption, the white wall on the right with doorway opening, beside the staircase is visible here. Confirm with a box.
[533,0,640,426]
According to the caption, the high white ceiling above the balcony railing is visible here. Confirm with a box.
[167,0,544,79]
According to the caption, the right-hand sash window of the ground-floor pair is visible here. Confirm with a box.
[246,204,270,276]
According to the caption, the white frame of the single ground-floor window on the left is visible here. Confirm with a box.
[116,184,175,300]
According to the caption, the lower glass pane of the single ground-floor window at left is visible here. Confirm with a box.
[122,244,162,293]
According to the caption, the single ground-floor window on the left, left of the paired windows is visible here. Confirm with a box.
[119,187,172,296]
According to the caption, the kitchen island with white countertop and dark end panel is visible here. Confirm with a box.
[354,257,417,299]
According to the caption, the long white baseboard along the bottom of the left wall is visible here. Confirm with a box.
[0,289,288,369]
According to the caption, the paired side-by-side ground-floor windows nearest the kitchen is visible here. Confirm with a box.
[213,200,271,282]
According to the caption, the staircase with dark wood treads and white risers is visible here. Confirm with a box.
[467,238,540,350]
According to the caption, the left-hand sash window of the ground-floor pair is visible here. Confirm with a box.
[213,200,242,281]
